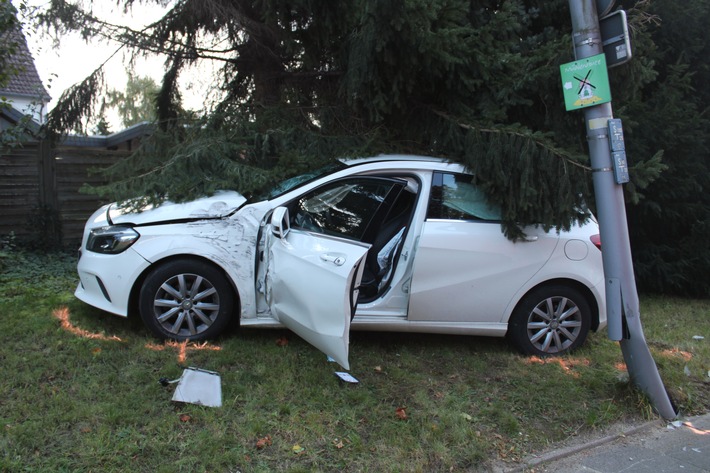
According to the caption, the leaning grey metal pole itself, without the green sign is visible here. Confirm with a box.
[569,0,678,419]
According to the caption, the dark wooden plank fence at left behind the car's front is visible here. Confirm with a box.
[0,142,130,247]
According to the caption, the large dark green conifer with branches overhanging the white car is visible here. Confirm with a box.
[32,0,588,232]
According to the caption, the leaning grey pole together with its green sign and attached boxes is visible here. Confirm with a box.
[560,0,678,419]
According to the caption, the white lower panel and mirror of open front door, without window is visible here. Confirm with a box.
[265,207,370,369]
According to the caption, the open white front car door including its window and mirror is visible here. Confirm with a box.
[264,177,406,369]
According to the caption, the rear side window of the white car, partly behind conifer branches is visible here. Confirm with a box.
[427,172,500,222]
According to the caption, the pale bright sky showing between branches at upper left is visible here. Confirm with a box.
[13,0,210,131]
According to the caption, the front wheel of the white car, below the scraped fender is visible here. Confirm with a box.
[139,259,235,341]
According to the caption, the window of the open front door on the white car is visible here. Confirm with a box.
[291,178,401,240]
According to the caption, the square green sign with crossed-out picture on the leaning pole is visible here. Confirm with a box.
[560,54,611,111]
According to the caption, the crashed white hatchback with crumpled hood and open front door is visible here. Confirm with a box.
[76,156,606,368]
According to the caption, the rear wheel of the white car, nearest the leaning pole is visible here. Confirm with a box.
[508,285,592,356]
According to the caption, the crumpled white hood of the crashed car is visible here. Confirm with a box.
[107,191,247,225]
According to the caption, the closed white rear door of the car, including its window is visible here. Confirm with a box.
[408,172,559,323]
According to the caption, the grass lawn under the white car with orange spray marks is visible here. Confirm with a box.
[0,250,710,472]
